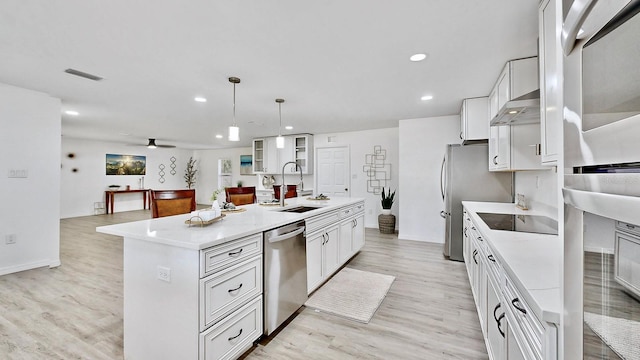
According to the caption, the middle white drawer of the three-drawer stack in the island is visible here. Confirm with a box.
[200,256,262,331]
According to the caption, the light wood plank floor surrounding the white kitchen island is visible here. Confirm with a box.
[0,210,488,360]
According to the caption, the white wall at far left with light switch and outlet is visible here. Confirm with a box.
[0,84,61,275]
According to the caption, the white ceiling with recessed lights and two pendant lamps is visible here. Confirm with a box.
[0,0,538,149]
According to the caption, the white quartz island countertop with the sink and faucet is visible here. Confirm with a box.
[96,197,364,250]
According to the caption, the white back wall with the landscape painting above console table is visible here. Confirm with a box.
[60,137,194,218]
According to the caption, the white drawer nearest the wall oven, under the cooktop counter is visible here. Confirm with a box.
[504,276,545,360]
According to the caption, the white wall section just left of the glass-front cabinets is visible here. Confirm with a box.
[193,147,258,204]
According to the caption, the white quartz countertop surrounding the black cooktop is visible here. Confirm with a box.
[462,201,563,324]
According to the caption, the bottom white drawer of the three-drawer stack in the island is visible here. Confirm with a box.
[200,296,263,360]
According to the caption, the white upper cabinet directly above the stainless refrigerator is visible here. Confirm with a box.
[460,97,489,144]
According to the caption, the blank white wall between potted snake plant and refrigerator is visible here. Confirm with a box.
[398,115,460,243]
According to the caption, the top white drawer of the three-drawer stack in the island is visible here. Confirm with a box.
[200,233,262,278]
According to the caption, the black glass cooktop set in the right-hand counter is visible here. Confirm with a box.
[478,213,558,235]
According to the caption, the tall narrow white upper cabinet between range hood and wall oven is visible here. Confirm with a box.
[538,0,563,166]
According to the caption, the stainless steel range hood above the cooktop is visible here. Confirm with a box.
[490,89,540,126]
